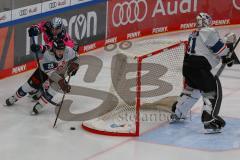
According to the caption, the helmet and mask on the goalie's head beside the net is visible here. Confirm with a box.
[196,13,212,28]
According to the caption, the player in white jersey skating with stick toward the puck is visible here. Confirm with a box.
[6,39,79,115]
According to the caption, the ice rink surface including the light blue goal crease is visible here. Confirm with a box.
[0,26,240,160]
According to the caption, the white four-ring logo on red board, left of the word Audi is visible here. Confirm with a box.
[112,0,148,27]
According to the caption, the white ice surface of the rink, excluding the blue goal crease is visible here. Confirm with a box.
[0,26,240,160]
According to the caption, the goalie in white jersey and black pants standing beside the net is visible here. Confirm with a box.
[171,13,236,131]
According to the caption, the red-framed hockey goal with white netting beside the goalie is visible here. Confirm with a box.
[82,42,186,136]
